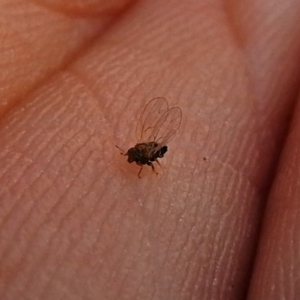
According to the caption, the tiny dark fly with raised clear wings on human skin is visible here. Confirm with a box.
[116,97,182,178]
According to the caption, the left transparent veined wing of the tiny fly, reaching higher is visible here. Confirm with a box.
[136,97,169,142]
